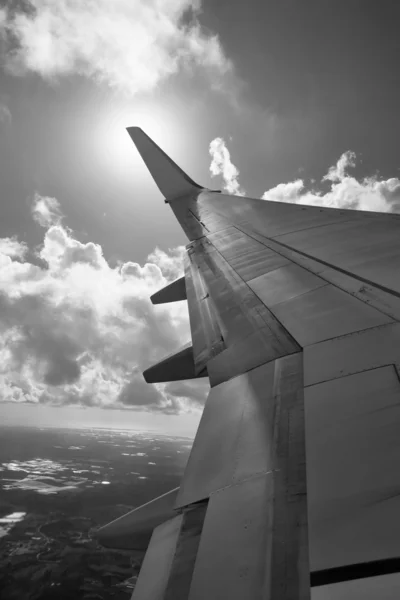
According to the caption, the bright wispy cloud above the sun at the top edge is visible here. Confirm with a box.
[0,0,232,94]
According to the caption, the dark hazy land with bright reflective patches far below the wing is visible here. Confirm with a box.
[0,427,192,600]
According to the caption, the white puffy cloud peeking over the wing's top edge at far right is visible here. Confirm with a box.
[262,151,400,212]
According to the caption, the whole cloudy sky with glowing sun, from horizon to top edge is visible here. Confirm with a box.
[0,0,400,435]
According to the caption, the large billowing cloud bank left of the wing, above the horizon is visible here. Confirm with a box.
[0,199,201,413]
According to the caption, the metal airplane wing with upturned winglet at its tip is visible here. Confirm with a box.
[100,127,400,600]
